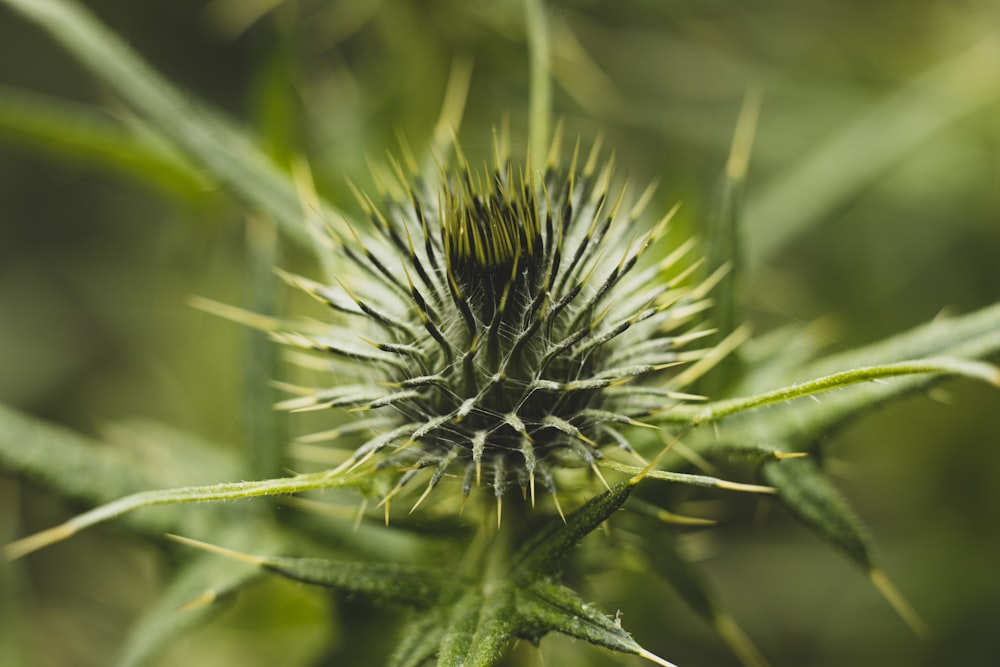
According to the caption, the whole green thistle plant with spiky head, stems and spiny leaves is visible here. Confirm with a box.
[0,0,1000,667]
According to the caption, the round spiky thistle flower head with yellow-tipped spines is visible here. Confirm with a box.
[276,136,724,506]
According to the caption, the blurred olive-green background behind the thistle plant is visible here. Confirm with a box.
[0,0,1000,666]
